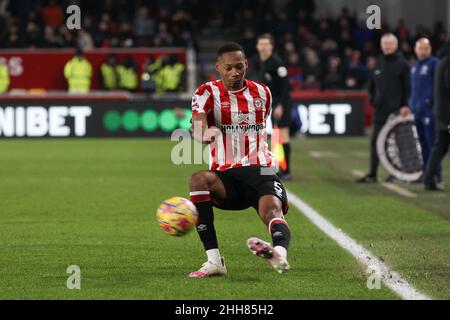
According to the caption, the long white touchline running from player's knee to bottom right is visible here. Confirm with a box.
[287,191,431,300]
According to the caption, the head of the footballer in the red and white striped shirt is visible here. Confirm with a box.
[216,42,248,90]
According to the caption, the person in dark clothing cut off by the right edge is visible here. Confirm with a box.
[424,42,450,191]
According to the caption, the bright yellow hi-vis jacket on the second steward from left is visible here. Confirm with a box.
[64,57,92,93]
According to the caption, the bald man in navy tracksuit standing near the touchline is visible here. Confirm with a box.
[409,38,441,182]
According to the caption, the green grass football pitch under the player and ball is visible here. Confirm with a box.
[0,138,450,299]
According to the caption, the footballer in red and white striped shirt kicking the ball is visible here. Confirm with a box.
[189,43,291,278]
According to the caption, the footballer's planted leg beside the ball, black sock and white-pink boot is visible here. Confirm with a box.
[189,170,226,278]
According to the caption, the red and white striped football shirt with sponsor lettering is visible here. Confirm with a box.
[192,80,275,171]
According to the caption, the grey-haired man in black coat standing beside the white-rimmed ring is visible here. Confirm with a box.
[356,33,410,183]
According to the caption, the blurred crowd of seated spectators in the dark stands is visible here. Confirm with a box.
[0,0,446,90]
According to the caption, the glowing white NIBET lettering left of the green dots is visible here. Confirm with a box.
[0,106,92,137]
